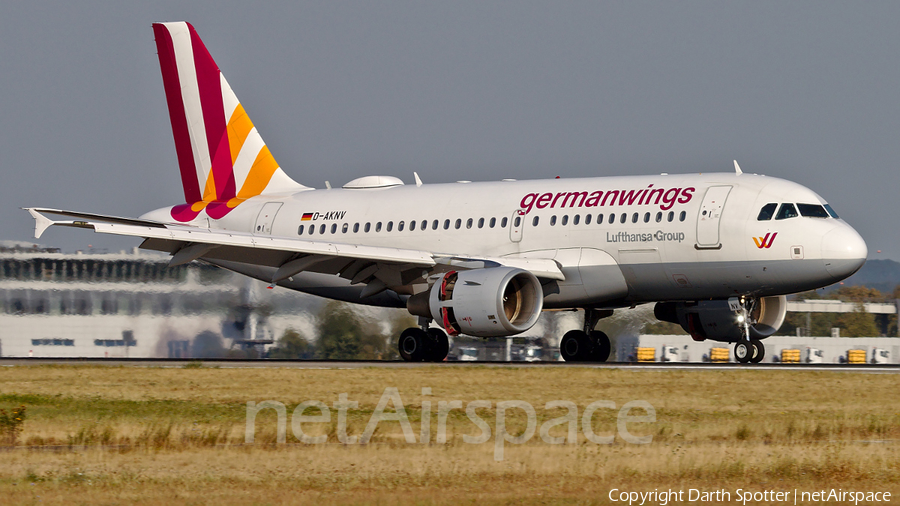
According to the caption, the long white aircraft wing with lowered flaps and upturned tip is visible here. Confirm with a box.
[26,208,565,296]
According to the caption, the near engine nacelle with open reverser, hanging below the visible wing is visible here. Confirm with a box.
[407,267,544,337]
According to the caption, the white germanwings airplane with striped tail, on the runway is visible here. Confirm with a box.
[26,22,867,363]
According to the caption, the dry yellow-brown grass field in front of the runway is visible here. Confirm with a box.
[0,366,900,504]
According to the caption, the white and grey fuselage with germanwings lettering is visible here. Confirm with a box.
[143,173,867,308]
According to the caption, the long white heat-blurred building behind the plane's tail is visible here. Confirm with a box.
[0,248,315,358]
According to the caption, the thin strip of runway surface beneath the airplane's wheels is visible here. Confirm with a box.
[0,358,900,374]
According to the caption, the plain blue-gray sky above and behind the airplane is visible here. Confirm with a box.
[0,0,900,260]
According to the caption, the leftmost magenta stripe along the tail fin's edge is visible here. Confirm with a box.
[153,23,203,202]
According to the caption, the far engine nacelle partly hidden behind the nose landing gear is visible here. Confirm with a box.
[653,295,787,343]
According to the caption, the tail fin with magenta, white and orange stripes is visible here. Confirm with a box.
[153,22,306,221]
